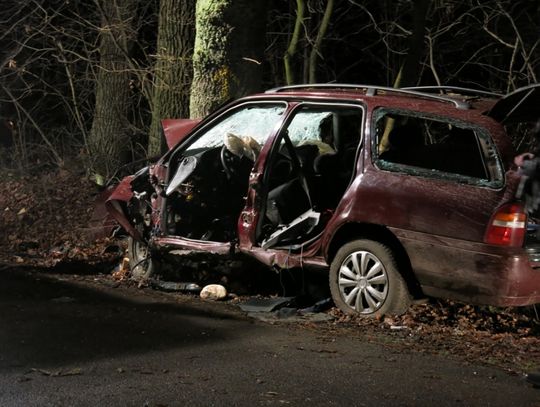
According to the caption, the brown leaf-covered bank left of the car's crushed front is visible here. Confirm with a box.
[0,170,117,267]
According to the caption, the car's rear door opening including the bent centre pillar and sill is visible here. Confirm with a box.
[239,103,363,268]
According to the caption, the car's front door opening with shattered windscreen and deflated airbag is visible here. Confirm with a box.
[152,102,286,254]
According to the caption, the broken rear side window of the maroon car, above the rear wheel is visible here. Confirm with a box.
[373,111,504,187]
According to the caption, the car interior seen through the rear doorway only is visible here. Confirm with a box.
[259,107,362,250]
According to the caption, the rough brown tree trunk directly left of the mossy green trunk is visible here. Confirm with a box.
[148,0,196,155]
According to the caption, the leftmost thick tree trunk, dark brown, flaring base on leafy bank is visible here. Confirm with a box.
[87,0,136,183]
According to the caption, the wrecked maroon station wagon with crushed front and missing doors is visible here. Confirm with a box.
[107,84,540,316]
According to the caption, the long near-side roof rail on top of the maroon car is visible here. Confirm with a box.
[266,83,471,109]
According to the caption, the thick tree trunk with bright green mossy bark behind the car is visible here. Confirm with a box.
[190,0,267,118]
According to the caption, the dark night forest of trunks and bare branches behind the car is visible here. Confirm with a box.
[0,0,540,184]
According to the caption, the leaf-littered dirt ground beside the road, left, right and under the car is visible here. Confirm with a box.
[0,167,540,375]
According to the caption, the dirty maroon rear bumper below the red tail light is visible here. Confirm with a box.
[394,230,540,306]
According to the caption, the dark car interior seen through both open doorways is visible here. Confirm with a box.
[159,106,362,249]
